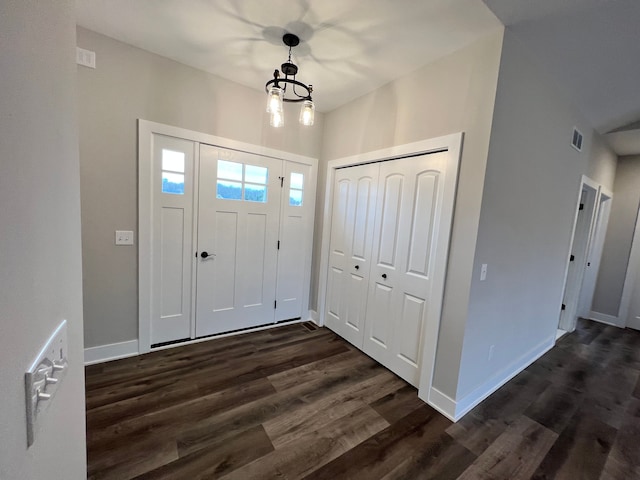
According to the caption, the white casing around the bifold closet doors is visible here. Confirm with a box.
[317,132,464,399]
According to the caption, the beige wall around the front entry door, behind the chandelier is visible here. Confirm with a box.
[78,28,323,347]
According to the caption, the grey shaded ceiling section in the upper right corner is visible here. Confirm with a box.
[484,0,640,139]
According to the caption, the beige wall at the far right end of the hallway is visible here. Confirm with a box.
[591,156,640,317]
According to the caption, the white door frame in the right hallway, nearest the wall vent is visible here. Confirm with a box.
[558,175,600,332]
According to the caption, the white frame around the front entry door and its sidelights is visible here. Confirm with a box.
[138,119,318,354]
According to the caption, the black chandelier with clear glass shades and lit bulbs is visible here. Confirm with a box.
[264,33,315,128]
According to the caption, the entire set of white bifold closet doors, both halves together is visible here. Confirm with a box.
[326,152,451,386]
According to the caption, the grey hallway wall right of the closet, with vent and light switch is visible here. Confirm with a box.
[455,29,616,403]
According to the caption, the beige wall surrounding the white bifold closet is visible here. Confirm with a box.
[320,29,502,393]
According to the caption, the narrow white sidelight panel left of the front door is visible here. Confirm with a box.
[150,134,195,345]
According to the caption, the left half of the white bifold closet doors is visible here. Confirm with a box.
[326,163,380,348]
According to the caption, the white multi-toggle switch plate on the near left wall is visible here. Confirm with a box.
[24,320,68,447]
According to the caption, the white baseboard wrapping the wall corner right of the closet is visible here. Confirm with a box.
[428,335,555,422]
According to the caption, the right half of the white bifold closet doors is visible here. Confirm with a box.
[363,152,451,386]
